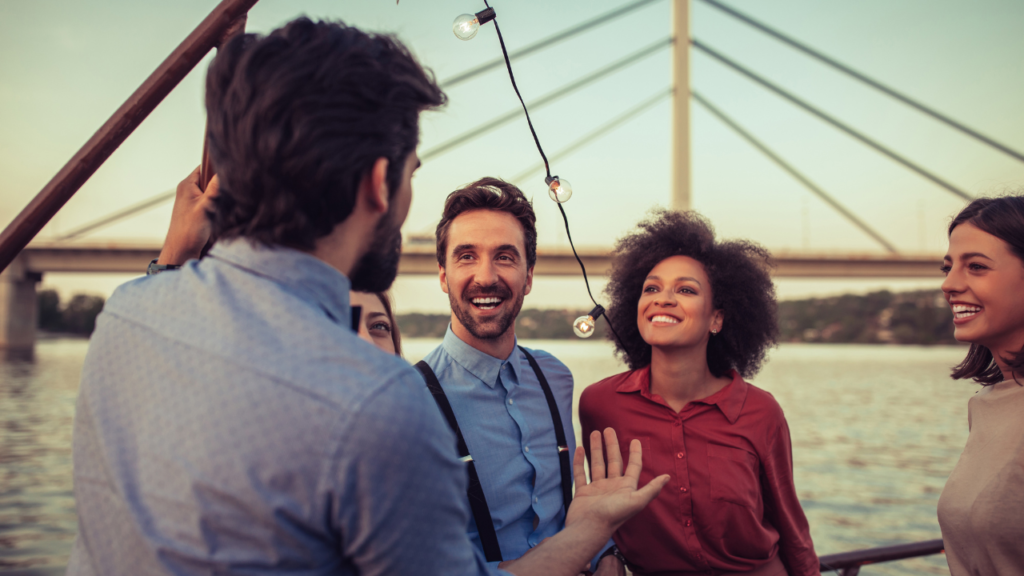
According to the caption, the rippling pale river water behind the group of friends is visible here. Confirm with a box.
[0,339,977,576]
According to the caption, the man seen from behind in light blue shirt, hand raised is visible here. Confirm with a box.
[68,18,664,575]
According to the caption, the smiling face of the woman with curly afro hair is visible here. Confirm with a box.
[637,256,723,347]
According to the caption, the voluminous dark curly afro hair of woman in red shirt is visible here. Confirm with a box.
[605,209,778,378]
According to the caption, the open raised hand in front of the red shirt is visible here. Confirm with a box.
[565,428,669,531]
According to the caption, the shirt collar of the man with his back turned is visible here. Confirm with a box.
[210,238,352,328]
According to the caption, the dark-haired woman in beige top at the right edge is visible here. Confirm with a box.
[938,196,1024,576]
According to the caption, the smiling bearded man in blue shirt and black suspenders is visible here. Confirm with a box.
[417,177,626,575]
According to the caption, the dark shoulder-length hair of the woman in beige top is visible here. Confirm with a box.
[949,196,1024,386]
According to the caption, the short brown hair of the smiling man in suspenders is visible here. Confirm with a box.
[435,177,537,269]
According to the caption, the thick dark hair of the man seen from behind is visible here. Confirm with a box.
[206,17,445,250]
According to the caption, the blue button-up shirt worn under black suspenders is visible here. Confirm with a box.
[423,326,610,568]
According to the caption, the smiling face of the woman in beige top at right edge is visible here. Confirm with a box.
[942,223,1024,353]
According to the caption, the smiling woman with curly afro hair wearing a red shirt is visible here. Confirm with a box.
[580,211,819,576]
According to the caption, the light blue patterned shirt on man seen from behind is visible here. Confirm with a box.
[68,241,497,576]
